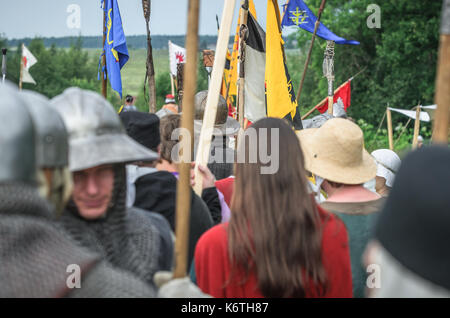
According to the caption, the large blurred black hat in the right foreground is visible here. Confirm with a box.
[375,146,450,290]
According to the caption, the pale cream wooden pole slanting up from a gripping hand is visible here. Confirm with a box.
[194,0,236,196]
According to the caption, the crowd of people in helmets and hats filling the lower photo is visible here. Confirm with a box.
[0,83,450,298]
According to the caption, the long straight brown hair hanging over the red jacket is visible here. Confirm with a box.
[228,118,326,297]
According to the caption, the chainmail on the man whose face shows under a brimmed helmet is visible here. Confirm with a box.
[61,165,161,285]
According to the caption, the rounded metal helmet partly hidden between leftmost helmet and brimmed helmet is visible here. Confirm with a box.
[20,91,69,168]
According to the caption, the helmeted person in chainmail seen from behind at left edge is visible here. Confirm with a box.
[0,84,155,297]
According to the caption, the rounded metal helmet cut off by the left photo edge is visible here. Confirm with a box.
[0,83,36,183]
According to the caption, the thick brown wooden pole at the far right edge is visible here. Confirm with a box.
[432,0,450,144]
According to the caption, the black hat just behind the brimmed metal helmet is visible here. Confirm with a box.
[119,112,161,151]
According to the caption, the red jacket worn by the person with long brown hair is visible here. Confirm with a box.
[195,207,353,298]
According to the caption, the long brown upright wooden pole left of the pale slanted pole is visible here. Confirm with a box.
[173,0,200,278]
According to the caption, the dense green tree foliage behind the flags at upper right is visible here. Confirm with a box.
[289,0,442,125]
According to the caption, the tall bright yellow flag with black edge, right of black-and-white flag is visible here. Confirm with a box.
[265,0,301,124]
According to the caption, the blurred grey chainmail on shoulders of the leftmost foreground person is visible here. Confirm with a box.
[0,183,155,297]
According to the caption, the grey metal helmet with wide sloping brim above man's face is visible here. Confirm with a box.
[51,87,158,171]
